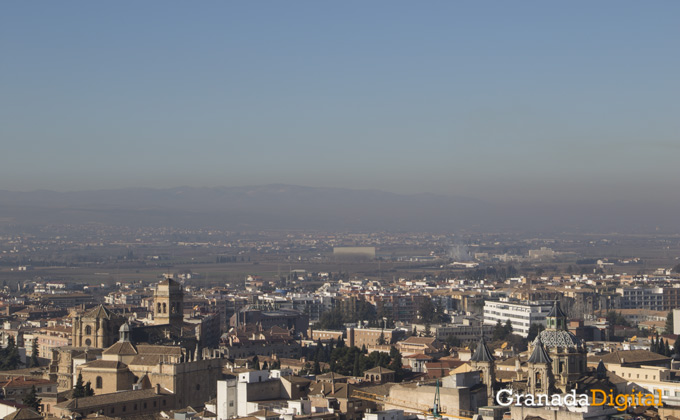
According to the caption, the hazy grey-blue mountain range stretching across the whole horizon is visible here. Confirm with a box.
[0,184,680,233]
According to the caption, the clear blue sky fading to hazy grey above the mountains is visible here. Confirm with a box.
[0,1,680,202]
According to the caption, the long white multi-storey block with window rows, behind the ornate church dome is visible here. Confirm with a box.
[484,301,553,337]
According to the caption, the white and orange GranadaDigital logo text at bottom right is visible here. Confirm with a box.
[496,389,662,411]
